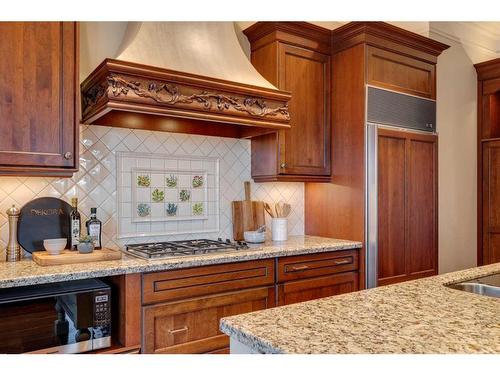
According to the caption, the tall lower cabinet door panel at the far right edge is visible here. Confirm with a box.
[481,141,500,264]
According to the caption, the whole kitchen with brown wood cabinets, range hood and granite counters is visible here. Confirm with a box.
[0,0,500,374]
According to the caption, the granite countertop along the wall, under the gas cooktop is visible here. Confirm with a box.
[0,236,362,288]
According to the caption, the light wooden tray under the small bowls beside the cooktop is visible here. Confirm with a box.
[32,248,122,266]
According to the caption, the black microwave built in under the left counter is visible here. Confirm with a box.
[0,279,111,354]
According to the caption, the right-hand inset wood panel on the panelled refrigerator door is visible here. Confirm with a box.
[407,135,437,276]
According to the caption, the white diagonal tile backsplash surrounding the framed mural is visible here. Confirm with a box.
[0,125,304,260]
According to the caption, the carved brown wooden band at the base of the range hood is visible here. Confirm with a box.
[81,59,291,138]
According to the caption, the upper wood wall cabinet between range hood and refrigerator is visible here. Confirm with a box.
[244,22,331,182]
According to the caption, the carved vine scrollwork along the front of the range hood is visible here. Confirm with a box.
[107,75,290,120]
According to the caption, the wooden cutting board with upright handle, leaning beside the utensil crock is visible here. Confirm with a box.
[233,181,265,241]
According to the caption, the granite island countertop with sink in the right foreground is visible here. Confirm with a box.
[220,263,500,353]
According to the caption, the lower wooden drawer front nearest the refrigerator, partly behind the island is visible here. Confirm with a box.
[278,272,359,306]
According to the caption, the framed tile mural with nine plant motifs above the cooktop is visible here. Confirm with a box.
[116,152,219,238]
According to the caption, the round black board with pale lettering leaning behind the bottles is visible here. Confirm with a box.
[17,197,71,253]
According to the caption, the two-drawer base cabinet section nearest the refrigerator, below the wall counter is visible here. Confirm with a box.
[277,250,359,306]
